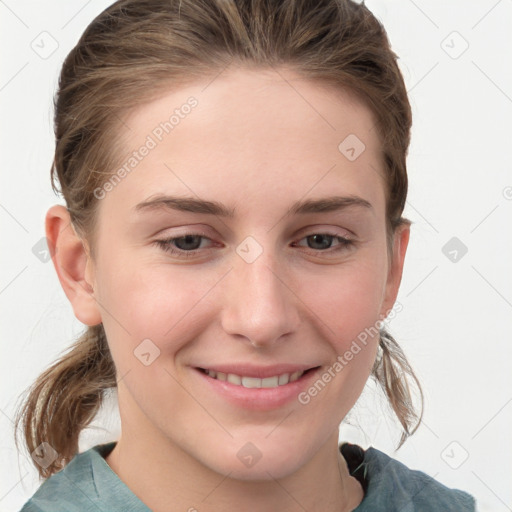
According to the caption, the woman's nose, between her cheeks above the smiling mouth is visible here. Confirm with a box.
[221,247,300,348]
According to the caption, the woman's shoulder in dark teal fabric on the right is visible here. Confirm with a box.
[356,447,476,512]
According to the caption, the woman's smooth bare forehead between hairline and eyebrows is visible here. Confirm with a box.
[102,64,383,216]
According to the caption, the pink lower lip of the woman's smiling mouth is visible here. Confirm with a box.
[193,367,320,411]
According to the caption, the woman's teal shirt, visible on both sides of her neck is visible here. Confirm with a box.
[21,441,476,512]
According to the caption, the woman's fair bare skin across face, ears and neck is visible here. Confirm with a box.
[46,68,409,512]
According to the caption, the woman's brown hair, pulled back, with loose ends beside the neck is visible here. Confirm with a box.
[15,0,423,478]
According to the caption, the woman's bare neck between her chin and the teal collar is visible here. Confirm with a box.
[106,431,363,512]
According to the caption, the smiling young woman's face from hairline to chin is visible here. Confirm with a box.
[87,68,408,479]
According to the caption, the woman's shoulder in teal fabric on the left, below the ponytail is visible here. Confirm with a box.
[20,444,120,512]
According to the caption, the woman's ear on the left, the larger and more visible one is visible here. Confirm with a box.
[46,205,101,326]
